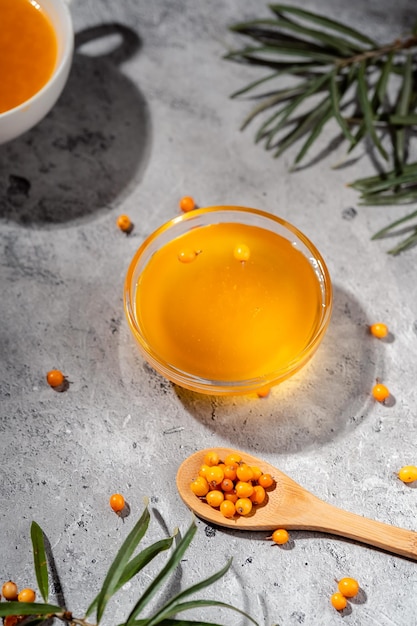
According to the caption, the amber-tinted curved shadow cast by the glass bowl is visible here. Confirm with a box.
[175,286,384,454]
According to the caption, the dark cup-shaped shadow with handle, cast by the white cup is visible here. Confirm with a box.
[0,24,151,228]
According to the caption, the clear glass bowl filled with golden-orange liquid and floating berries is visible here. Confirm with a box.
[124,206,332,395]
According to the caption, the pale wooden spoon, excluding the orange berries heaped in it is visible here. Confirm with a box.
[177,448,417,559]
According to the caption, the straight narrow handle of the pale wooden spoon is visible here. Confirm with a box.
[306,498,417,560]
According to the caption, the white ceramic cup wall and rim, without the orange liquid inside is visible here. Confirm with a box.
[0,0,74,144]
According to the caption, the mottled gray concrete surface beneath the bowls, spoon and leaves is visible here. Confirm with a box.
[0,0,417,626]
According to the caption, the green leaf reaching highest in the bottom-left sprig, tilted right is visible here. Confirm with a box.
[94,507,150,623]
